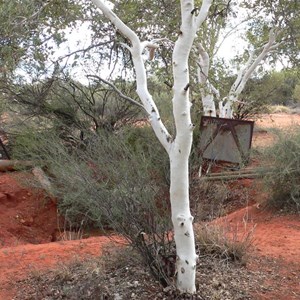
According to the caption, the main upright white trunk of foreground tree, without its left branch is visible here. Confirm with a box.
[169,1,210,293]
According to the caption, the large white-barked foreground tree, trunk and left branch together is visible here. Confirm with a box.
[92,0,212,293]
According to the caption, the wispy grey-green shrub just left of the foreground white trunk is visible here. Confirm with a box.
[14,128,175,286]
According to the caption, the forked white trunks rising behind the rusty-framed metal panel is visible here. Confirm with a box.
[198,29,280,119]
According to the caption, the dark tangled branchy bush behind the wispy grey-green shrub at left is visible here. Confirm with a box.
[2,73,144,145]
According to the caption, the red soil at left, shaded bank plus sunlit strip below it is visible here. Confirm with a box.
[0,172,120,300]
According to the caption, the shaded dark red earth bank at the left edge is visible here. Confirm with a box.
[0,173,57,248]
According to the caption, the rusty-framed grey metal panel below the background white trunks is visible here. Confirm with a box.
[199,116,254,164]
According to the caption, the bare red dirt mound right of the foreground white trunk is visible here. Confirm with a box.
[216,205,300,262]
